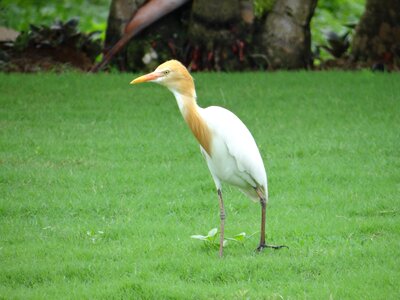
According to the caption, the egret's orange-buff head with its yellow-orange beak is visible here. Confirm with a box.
[131,60,194,95]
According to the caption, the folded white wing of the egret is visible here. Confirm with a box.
[203,106,267,189]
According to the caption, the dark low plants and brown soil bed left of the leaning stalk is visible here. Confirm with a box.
[0,19,102,72]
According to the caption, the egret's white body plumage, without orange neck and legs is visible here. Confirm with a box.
[200,106,268,200]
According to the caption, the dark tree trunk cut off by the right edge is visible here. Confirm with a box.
[352,0,400,68]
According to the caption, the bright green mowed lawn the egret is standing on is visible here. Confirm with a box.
[0,72,400,299]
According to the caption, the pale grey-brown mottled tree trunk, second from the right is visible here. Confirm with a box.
[262,0,317,69]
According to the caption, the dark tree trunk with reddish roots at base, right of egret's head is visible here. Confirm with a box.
[189,0,254,71]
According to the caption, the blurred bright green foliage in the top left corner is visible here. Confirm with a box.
[0,0,109,39]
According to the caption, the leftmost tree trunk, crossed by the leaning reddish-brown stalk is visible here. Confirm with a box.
[106,0,191,71]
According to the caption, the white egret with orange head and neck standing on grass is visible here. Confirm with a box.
[131,60,285,257]
